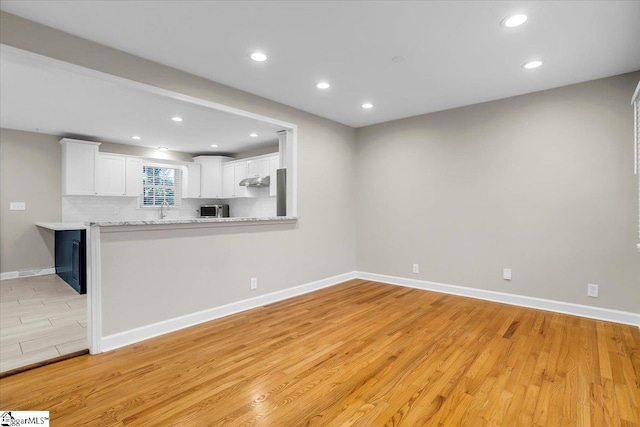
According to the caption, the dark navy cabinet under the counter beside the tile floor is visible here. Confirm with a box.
[55,230,87,294]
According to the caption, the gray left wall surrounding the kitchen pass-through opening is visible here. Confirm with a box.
[0,13,355,335]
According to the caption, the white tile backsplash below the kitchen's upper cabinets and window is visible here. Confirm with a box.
[62,194,276,221]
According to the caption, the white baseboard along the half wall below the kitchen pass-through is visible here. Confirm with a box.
[100,272,356,352]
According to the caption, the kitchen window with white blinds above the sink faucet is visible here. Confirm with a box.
[141,166,181,207]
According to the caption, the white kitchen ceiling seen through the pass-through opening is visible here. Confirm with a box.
[0,47,283,153]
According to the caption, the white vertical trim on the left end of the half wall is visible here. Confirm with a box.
[86,225,102,354]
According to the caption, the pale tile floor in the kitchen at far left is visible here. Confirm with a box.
[0,274,87,372]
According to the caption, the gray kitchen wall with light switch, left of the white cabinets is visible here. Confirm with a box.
[0,129,62,273]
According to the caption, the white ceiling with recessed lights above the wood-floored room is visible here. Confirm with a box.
[1,0,640,127]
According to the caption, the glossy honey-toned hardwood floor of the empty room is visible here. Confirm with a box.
[0,280,640,427]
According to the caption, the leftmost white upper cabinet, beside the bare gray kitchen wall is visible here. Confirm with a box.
[60,138,100,196]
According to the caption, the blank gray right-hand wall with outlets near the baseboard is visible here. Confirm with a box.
[356,72,640,313]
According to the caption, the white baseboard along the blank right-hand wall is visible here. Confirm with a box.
[354,271,640,327]
